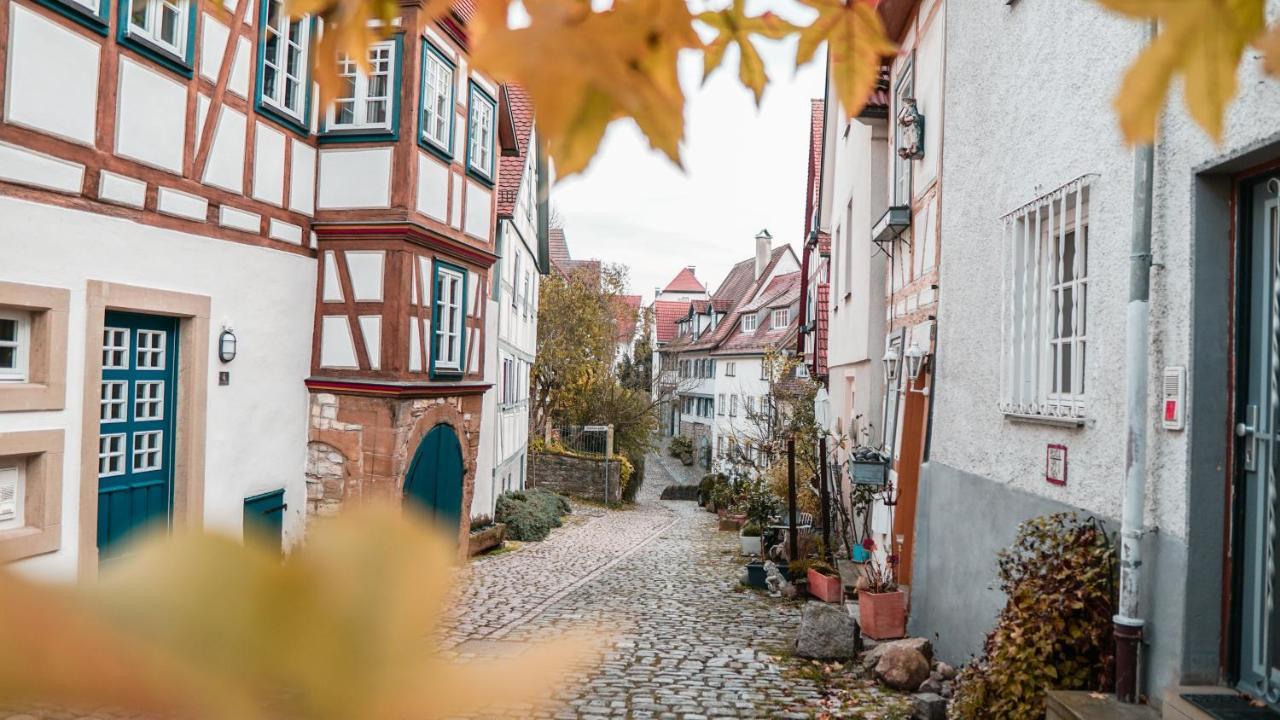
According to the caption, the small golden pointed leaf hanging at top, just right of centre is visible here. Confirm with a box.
[796,0,897,118]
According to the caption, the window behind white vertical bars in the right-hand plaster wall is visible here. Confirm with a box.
[1001,176,1094,418]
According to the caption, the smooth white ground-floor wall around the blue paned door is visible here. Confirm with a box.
[0,192,315,579]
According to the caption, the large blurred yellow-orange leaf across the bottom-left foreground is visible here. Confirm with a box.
[0,506,590,720]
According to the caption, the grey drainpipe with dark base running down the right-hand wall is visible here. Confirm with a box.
[1114,22,1156,703]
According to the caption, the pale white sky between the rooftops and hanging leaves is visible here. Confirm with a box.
[552,0,824,304]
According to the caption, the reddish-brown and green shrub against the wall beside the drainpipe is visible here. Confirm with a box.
[948,512,1116,720]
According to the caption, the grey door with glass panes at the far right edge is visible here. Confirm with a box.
[1234,170,1280,703]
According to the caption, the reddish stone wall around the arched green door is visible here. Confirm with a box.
[306,392,481,547]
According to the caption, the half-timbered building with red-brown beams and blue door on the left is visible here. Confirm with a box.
[0,0,515,577]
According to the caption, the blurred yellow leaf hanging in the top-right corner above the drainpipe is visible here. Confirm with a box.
[1098,0,1266,143]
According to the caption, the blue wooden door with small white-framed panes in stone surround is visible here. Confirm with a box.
[97,311,178,561]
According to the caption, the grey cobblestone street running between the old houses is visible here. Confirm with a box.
[445,455,818,720]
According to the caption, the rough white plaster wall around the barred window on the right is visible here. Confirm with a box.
[932,0,1280,538]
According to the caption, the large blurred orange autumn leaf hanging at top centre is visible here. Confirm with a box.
[472,0,700,176]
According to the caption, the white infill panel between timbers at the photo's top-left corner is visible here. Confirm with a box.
[4,4,101,145]
